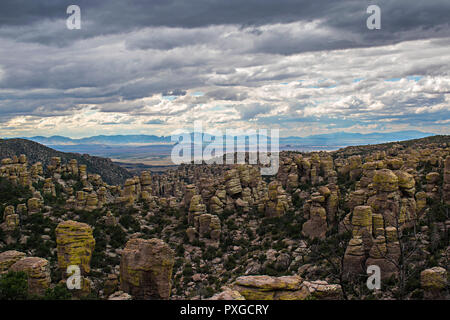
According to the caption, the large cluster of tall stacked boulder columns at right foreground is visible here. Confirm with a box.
[344,168,417,279]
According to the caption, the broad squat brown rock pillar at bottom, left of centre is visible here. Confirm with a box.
[120,239,174,300]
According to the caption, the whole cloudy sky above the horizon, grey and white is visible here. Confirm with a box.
[0,0,450,137]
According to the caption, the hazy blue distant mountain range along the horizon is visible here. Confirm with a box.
[18,130,435,149]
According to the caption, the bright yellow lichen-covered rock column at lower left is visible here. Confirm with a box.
[55,220,95,274]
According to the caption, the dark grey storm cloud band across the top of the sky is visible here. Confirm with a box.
[0,0,450,49]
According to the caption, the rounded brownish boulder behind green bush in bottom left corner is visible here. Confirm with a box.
[10,257,51,295]
